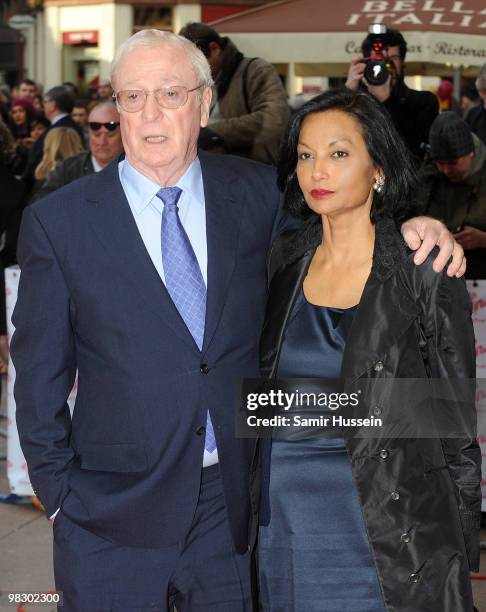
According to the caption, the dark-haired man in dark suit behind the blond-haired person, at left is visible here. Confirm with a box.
[23,85,84,186]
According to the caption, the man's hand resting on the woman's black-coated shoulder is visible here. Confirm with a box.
[401,217,466,278]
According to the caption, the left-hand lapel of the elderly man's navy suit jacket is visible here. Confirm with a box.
[86,160,199,351]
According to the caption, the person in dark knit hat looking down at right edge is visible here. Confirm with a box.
[417,112,486,279]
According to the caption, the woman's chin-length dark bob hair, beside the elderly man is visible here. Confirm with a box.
[278,89,417,223]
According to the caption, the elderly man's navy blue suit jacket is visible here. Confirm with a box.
[11,153,280,552]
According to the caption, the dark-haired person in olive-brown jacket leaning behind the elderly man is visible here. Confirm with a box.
[180,23,290,164]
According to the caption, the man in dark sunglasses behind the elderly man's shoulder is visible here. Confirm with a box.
[34,102,123,201]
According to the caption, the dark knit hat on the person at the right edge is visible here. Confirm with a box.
[429,111,474,161]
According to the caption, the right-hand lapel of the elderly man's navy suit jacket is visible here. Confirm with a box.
[199,152,241,353]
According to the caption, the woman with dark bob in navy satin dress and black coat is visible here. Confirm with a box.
[253,90,481,612]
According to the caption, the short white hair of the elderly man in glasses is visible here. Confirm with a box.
[110,29,213,93]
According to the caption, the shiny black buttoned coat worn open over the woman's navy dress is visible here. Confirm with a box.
[251,218,481,612]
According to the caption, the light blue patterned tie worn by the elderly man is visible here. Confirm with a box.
[157,187,216,453]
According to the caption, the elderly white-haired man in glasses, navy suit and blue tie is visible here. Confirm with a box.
[12,30,463,612]
